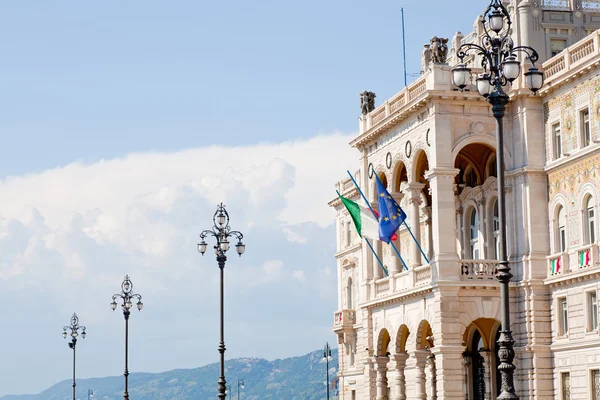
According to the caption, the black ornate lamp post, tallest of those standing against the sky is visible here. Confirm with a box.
[198,203,246,400]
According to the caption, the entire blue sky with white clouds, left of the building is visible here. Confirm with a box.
[0,0,488,396]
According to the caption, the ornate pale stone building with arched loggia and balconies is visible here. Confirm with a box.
[330,0,600,400]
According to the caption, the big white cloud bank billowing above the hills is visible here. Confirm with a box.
[0,134,358,394]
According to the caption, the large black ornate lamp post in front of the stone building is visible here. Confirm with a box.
[452,0,544,400]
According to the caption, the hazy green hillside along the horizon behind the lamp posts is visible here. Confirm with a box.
[0,350,337,400]
